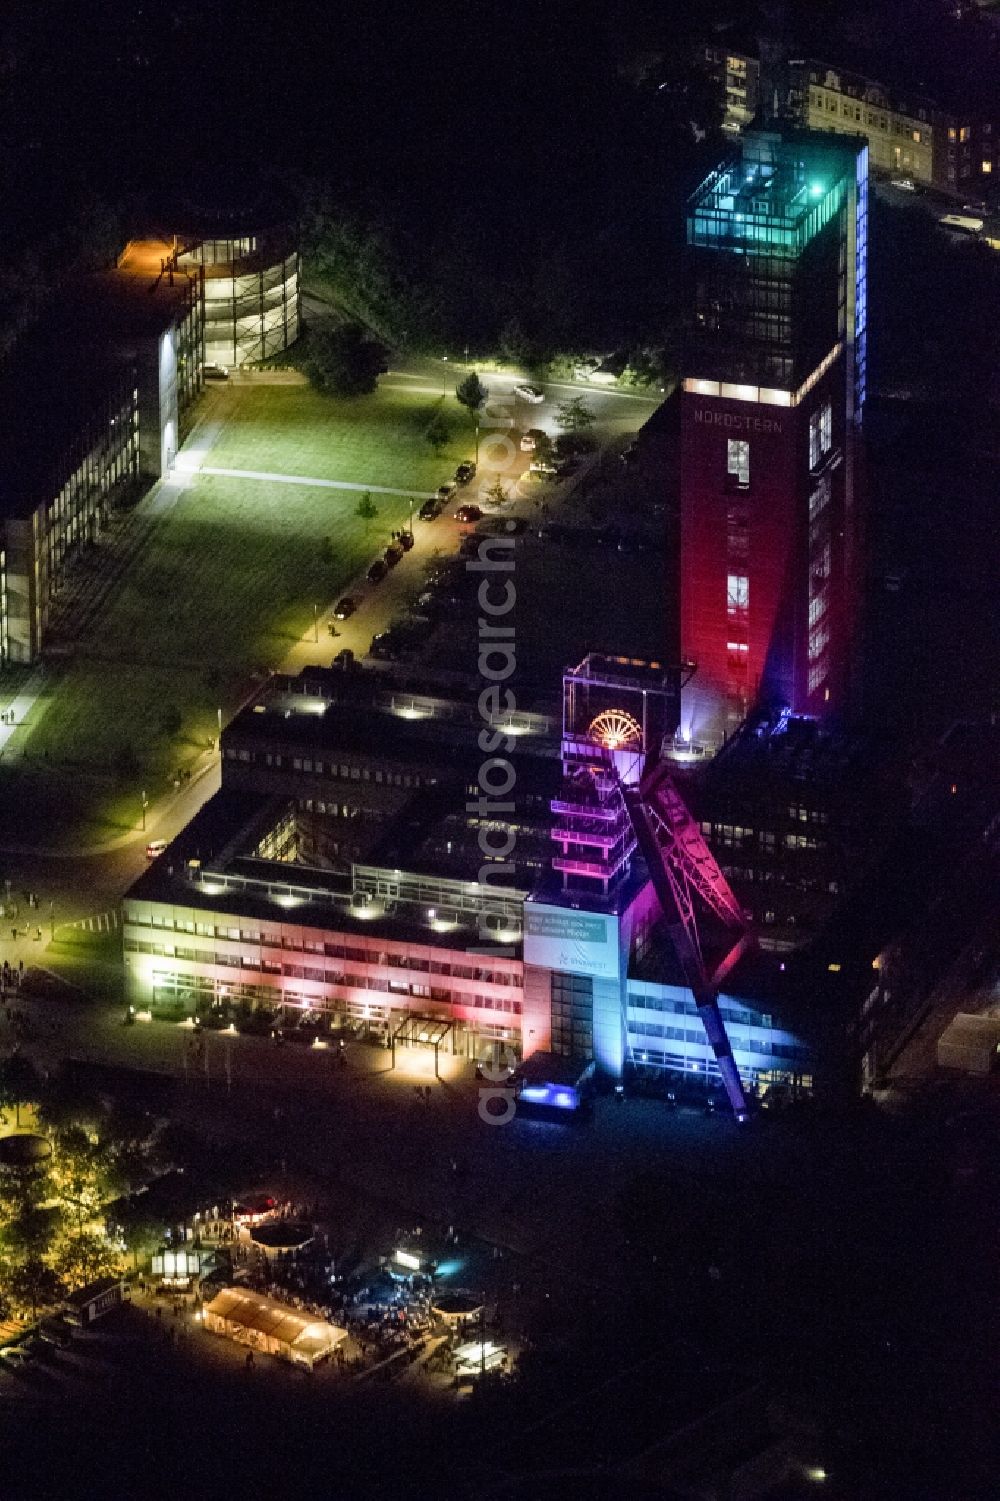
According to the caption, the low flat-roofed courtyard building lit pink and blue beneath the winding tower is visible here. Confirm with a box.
[123,659,812,1088]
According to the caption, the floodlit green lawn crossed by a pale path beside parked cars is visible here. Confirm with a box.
[0,386,464,841]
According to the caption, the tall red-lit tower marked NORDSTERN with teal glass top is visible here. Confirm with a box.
[680,131,868,744]
